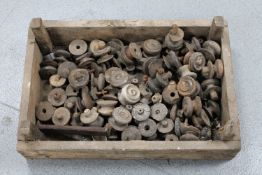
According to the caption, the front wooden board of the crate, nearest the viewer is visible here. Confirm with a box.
[17,141,240,159]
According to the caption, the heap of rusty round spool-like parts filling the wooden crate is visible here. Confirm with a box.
[36,24,227,141]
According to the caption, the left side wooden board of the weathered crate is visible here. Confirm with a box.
[17,29,42,140]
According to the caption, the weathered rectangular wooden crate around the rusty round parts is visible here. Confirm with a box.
[17,17,240,159]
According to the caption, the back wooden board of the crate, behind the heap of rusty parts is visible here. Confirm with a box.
[43,20,211,46]
